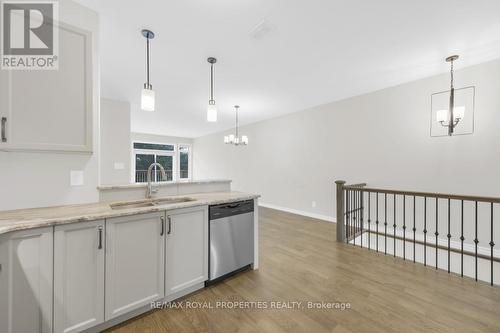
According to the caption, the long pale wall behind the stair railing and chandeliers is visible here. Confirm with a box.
[194,60,500,218]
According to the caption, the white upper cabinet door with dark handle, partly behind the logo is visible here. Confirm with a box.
[0,23,95,153]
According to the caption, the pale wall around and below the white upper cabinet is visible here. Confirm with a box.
[0,0,100,210]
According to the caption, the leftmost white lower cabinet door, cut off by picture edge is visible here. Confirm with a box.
[0,227,53,333]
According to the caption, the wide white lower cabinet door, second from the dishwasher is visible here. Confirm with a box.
[105,212,165,320]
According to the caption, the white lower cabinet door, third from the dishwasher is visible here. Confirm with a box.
[54,220,105,333]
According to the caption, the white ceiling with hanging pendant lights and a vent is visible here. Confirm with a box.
[79,0,500,137]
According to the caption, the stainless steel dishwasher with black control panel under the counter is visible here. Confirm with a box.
[207,200,254,284]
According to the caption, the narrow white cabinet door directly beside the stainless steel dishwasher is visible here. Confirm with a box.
[165,206,208,295]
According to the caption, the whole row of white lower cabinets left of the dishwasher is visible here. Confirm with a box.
[0,206,208,333]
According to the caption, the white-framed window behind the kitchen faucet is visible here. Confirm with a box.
[132,142,191,183]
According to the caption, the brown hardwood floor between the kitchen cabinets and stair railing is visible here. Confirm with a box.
[104,208,500,333]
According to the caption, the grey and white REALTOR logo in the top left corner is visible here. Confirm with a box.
[1,1,59,70]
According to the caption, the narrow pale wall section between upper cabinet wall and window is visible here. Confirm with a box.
[100,99,131,185]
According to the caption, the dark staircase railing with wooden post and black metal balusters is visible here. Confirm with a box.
[335,180,500,285]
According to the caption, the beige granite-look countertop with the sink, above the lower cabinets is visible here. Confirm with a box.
[0,191,259,234]
